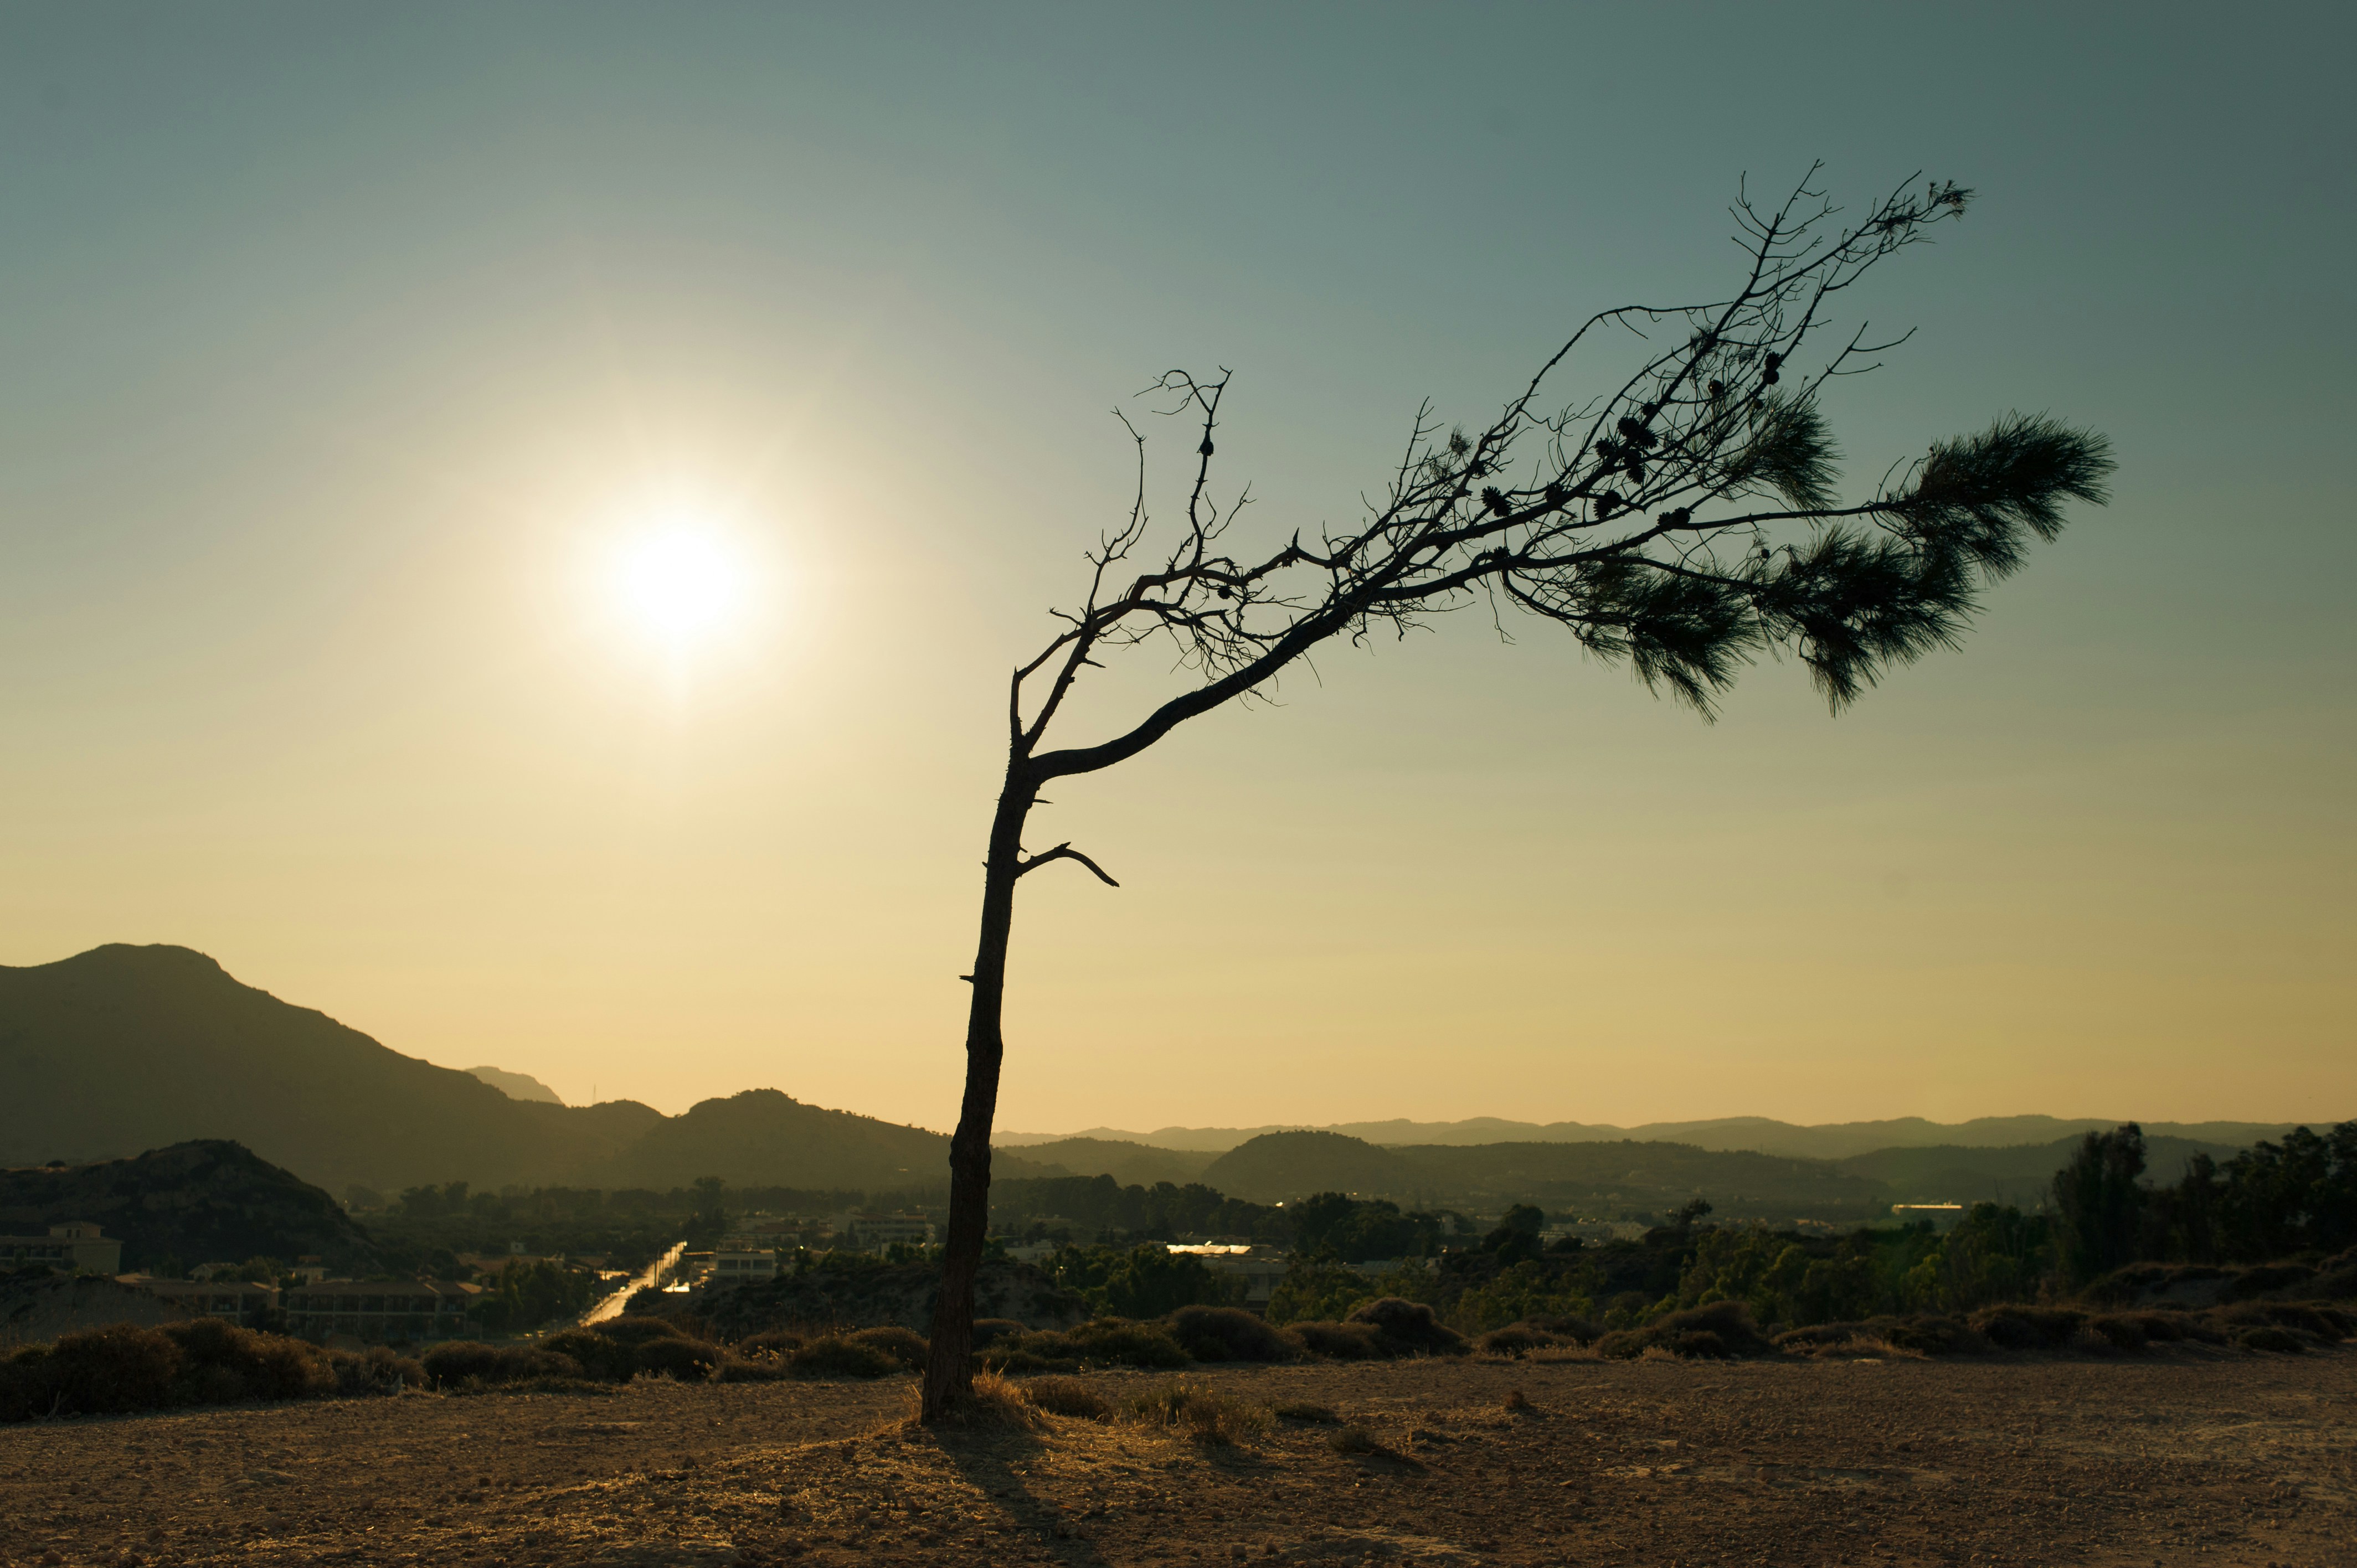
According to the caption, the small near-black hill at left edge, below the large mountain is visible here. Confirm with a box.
[0,1139,382,1276]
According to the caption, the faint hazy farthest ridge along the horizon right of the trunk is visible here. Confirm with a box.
[997,1115,2338,1160]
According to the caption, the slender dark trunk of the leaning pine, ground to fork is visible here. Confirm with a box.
[922,757,1032,1422]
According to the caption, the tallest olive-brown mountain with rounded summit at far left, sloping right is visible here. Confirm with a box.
[0,946,662,1191]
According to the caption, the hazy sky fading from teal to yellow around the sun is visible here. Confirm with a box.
[0,0,2357,1129]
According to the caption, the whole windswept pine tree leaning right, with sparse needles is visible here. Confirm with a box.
[924,170,2112,1420]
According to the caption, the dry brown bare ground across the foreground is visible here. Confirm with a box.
[0,1349,2357,1568]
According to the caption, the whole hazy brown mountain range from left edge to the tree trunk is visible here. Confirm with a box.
[0,946,1027,1193]
